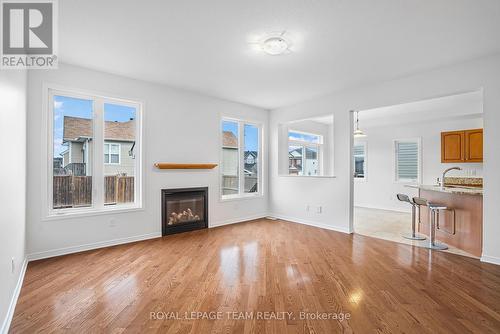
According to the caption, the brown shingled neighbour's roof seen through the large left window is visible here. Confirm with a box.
[63,116,135,141]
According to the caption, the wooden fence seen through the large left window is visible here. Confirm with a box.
[53,175,134,209]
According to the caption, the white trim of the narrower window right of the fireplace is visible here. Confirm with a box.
[219,117,264,202]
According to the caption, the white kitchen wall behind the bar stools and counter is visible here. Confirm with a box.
[354,116,483,212]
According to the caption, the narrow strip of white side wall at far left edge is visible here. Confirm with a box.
[0,71,27,333]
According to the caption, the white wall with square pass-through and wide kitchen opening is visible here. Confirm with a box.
[270,55,500,264]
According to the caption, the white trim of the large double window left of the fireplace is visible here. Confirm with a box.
[40,82,144,221]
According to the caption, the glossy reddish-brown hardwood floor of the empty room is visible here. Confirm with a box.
[10,220,500,333]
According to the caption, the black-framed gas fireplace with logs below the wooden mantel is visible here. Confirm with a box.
[161,187,208,235]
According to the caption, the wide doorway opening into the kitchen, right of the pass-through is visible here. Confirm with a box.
[351,91,483,257]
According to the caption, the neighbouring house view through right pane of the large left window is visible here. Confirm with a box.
[104,103,136,205]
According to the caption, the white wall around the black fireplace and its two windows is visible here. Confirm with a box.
[27,64,268,257]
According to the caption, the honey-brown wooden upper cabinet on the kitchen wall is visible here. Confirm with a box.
[441,129,483,163]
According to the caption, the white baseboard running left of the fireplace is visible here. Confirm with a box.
[27,232,161,261]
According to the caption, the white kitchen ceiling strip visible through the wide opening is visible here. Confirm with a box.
[359,91,483,129]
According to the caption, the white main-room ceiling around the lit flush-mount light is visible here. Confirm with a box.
[59,0,500,109]
